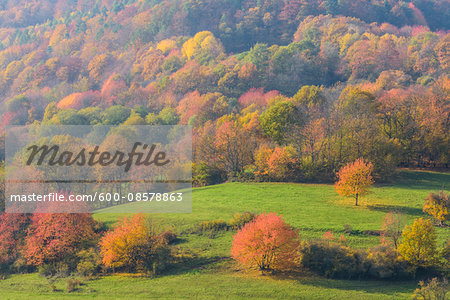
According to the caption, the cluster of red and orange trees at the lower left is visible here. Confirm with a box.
[0,213,174,276]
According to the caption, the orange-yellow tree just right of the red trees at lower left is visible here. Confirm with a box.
[100,214,169,272]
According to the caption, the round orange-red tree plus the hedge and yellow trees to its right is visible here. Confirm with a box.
[231,213,450,279]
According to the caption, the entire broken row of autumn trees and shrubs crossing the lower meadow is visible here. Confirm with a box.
[0,206,444,279]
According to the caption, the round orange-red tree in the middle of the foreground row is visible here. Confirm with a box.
[231,213,299,271]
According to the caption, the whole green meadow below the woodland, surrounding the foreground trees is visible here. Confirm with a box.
[0,171,450,299]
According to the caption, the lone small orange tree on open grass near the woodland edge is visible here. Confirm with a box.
[335,158,373,206]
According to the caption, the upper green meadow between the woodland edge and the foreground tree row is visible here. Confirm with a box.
[95,171,450,248]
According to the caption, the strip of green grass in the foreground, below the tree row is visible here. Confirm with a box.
[1,270,415,299]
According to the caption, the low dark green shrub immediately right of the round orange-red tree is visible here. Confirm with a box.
[300,241,368,279]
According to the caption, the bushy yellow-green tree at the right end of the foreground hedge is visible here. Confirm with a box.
[398,218,437,267]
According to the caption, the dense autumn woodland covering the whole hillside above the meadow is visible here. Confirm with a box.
[0,0,450,185]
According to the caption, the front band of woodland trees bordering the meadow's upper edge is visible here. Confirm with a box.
[5,72,444,185]
